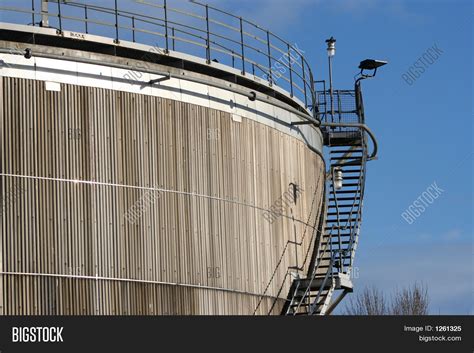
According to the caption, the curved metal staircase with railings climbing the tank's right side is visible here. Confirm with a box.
[282,81,373,315]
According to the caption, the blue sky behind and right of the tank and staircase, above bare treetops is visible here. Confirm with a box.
[1,0,474,314]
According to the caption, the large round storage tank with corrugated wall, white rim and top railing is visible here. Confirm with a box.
[0,2,325,315]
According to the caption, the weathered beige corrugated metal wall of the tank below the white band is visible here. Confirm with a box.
[0,77,324,315]
